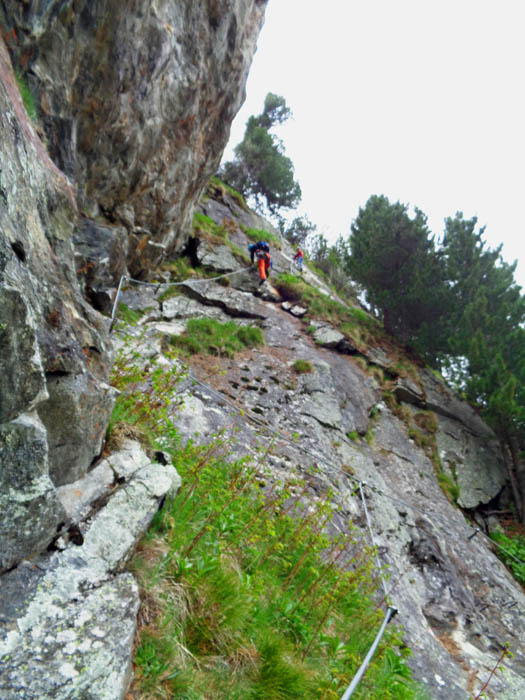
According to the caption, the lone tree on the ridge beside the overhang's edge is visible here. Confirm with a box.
[219,92,301,216]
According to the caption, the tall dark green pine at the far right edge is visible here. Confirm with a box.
[443,213,525,521]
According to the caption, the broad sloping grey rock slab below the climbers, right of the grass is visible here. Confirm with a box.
[100,208,525,700]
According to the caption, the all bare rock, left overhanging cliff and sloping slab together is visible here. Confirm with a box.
[0,0,525,700]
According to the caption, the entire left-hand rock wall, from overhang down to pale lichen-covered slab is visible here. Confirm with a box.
[0,0,266,700]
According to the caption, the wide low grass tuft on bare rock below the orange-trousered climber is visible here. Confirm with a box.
[170,318,264,357]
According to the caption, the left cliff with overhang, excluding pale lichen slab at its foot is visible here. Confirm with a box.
[0,0,265,570]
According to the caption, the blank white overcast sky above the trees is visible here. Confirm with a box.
[225,0,525,287]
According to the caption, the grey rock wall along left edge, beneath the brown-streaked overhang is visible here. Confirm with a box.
[0,39,113,570]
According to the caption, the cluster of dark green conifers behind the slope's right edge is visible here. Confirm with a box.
[298,195,525,522]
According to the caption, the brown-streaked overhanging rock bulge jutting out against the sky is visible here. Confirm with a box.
[0,0,266,266]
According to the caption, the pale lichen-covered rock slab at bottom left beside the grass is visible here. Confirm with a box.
[0,446,180,700]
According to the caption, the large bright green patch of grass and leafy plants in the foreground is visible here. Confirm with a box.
[104,334,423,700]
